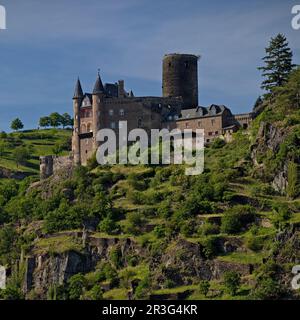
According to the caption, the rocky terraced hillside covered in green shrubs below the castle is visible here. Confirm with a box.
[0,71,300,299]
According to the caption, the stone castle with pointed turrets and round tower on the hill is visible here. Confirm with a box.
[72,53,253,165]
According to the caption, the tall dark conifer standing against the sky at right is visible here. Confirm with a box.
[258,33,295,93]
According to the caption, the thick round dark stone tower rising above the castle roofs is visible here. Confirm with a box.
[163,53,199,109]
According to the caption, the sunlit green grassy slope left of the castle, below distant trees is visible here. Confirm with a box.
[0,129,72,174]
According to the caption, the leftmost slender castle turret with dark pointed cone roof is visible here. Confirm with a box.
[73,78,83,165]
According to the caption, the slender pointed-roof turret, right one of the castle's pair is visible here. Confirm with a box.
[93,72,105,151]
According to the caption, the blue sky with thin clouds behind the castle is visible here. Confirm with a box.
[0,0,300,130]
